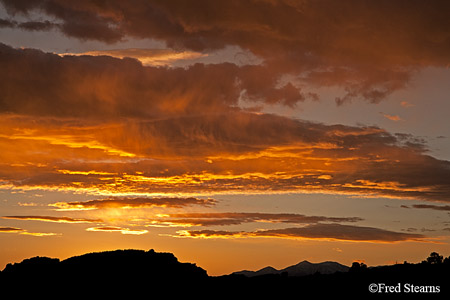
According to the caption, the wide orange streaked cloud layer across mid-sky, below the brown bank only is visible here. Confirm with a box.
[0,112,450,202]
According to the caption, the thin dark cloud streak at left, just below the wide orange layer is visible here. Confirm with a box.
[49,197,216,210]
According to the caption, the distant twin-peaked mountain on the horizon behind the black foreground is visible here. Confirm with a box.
[232,260,350,277]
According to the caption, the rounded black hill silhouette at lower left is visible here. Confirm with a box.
[0,250,208,298]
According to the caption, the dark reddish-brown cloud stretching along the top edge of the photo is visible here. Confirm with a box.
[1,0,449,63]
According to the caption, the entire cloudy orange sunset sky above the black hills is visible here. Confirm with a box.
[0,0,450,275]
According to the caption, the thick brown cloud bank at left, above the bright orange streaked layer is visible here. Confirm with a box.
[0,44,306,120]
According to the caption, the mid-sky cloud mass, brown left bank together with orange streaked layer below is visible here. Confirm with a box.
[0,40,450,204]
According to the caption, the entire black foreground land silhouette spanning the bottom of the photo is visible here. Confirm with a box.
[0,250,450,299]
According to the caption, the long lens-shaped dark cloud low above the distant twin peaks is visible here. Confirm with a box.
[178,224,425,243]
